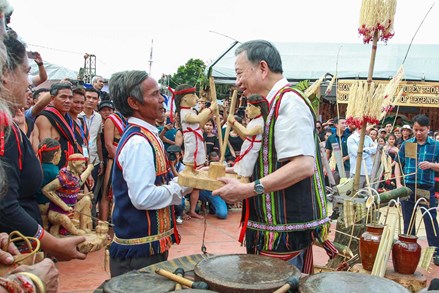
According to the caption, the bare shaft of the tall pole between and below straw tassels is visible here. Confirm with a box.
[353,30,378,193]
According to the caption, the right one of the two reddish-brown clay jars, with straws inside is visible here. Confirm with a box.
[392,234,421,275]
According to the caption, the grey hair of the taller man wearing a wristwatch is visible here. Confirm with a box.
[235,40,283,73]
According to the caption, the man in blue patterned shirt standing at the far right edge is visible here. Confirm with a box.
[395,114,439,266]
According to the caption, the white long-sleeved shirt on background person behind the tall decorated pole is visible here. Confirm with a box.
[346,131,377,176]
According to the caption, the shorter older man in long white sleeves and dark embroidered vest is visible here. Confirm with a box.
[110,71,189,277]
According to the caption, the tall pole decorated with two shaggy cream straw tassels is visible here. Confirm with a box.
[346,0,398,192]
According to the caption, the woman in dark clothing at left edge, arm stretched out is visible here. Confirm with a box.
[0,27,86,260]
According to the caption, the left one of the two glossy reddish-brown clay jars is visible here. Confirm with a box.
[360,224,384,271]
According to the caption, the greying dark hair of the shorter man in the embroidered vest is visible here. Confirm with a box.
[109,70,148,117]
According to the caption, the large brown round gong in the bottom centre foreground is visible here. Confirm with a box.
[194,254,301,293]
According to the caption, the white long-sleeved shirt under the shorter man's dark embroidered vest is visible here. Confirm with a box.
[115,117,183,210]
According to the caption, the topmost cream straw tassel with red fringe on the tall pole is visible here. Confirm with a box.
[358,0,396,43]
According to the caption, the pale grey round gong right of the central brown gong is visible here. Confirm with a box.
[299,272,410,293]
